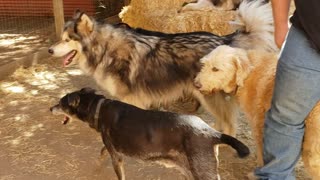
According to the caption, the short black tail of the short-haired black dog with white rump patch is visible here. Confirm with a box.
[220,134,250,158]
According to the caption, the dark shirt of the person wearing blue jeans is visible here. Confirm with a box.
[290,0,320,51]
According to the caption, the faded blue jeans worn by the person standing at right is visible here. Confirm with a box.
[255,27,320,180]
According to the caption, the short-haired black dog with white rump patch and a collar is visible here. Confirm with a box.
[50,88,249,180]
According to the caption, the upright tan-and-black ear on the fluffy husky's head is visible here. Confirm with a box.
[75,11,94,36]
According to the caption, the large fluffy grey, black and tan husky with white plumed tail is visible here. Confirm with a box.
[49,1,277,135]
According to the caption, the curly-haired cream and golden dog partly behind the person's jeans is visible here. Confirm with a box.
[195,45,320,179]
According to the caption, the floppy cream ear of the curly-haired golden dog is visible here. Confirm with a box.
[233,49,252,86]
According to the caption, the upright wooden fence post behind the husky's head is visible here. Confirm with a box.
[52,0,64,38]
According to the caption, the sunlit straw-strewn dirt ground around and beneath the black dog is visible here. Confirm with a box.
[0,58,309,180]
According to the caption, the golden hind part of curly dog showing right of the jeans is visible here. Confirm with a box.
[302,102,320,179]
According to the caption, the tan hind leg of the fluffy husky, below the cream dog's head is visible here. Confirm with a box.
[194,91,238,136]
